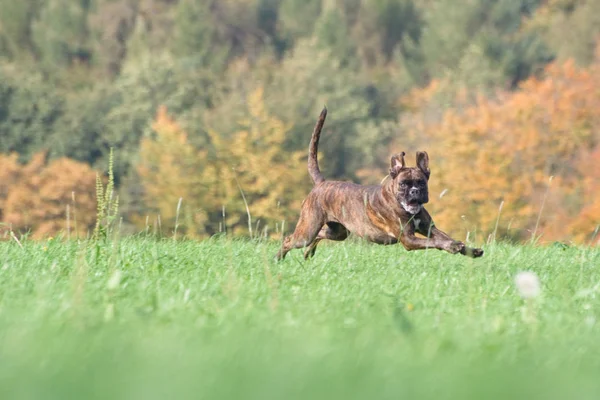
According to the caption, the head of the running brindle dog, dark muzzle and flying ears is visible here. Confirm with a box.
[390,151,430,214]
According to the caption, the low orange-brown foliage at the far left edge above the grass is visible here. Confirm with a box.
[0,152,96,238]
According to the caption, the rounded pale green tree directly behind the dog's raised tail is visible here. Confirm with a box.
[265,40,372,178]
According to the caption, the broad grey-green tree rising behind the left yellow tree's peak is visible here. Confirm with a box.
[60,53,212,182]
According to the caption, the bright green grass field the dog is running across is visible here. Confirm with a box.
[0,237,600,399]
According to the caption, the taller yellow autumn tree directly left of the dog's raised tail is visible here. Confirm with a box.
[203,88,309,238]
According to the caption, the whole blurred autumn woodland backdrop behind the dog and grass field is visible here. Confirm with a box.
[0,0,600,244]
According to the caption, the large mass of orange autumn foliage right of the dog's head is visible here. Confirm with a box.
[393,59,600,243]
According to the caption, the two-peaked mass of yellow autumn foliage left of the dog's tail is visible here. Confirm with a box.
[138,89,309,235]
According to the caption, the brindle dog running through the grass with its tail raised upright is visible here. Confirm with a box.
[275,108,483,260]
